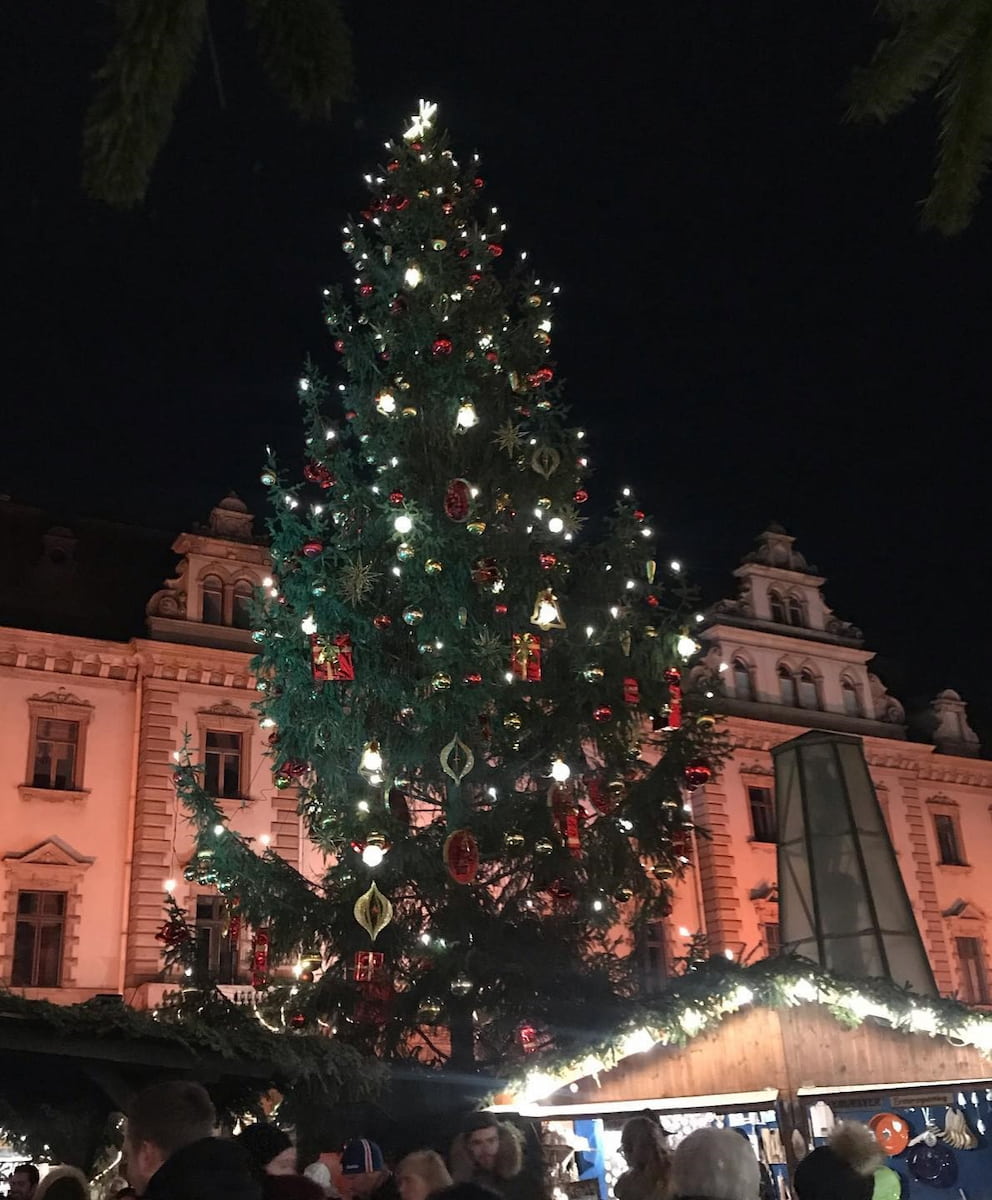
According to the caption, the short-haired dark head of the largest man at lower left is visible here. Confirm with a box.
[124,1079,217,1193]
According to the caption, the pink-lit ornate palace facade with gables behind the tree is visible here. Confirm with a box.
[0,497,992,1007]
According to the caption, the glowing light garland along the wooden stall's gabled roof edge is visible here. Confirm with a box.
[506,956,992,1103]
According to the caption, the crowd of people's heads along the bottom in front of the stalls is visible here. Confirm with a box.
[10,1080,884,1200]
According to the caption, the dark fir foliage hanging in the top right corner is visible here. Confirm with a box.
[848,0,992,235]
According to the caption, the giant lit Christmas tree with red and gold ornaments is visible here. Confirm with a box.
[179,102,719,1068]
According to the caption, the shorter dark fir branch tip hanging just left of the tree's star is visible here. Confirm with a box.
[247,0,353,120]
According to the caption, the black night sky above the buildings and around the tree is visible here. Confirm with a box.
[0,0,992,743]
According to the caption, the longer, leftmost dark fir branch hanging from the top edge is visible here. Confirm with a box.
[83,0,205,209]
